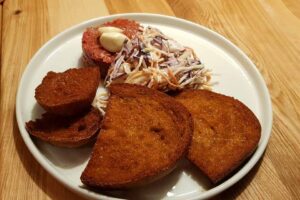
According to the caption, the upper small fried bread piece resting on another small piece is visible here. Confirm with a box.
[35,67,100,116]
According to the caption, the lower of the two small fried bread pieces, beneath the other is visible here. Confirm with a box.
[26,108,102,147]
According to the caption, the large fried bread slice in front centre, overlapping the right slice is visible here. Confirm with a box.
[81,84,193,189]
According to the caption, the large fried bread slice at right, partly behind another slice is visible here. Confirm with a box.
[176,90,261,183]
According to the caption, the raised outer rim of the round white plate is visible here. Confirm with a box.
[15,13,273,200]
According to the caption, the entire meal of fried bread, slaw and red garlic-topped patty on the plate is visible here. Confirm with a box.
[26,19,261,192]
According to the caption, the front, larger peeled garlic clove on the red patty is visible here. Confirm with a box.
[100,32,128,53]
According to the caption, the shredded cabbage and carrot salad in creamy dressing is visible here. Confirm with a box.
[94,26,211,113]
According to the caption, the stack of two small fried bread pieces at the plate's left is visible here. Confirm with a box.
[26,67,102,147]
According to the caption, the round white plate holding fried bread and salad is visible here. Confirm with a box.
[16,13,272,199]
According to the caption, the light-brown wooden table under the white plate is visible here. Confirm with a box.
[0,0,300,199]
